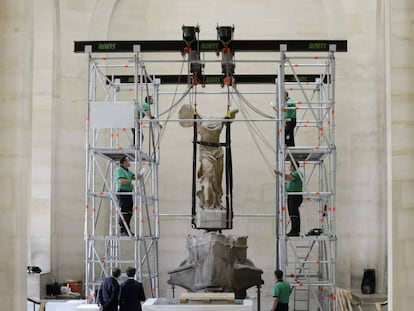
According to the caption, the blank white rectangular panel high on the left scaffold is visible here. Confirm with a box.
[89,102,134,128]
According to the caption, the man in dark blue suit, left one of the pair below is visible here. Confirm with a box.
[98,268,121,311]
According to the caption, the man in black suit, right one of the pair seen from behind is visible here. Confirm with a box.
[119,267,145,311]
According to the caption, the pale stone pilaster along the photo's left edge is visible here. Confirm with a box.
[0,0,33,311]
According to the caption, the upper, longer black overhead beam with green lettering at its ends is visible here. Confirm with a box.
[74,40,348,53]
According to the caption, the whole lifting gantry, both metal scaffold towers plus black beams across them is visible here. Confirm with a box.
[75,36,347,310]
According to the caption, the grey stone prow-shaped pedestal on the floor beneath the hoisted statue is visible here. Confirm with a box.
[168,232,263,299]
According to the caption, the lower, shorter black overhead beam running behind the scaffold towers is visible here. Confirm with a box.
[102,74,328,85]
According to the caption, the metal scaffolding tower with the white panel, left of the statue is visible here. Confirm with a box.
[84,46,160,302]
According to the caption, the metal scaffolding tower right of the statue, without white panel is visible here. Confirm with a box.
[276,45,337,310]
